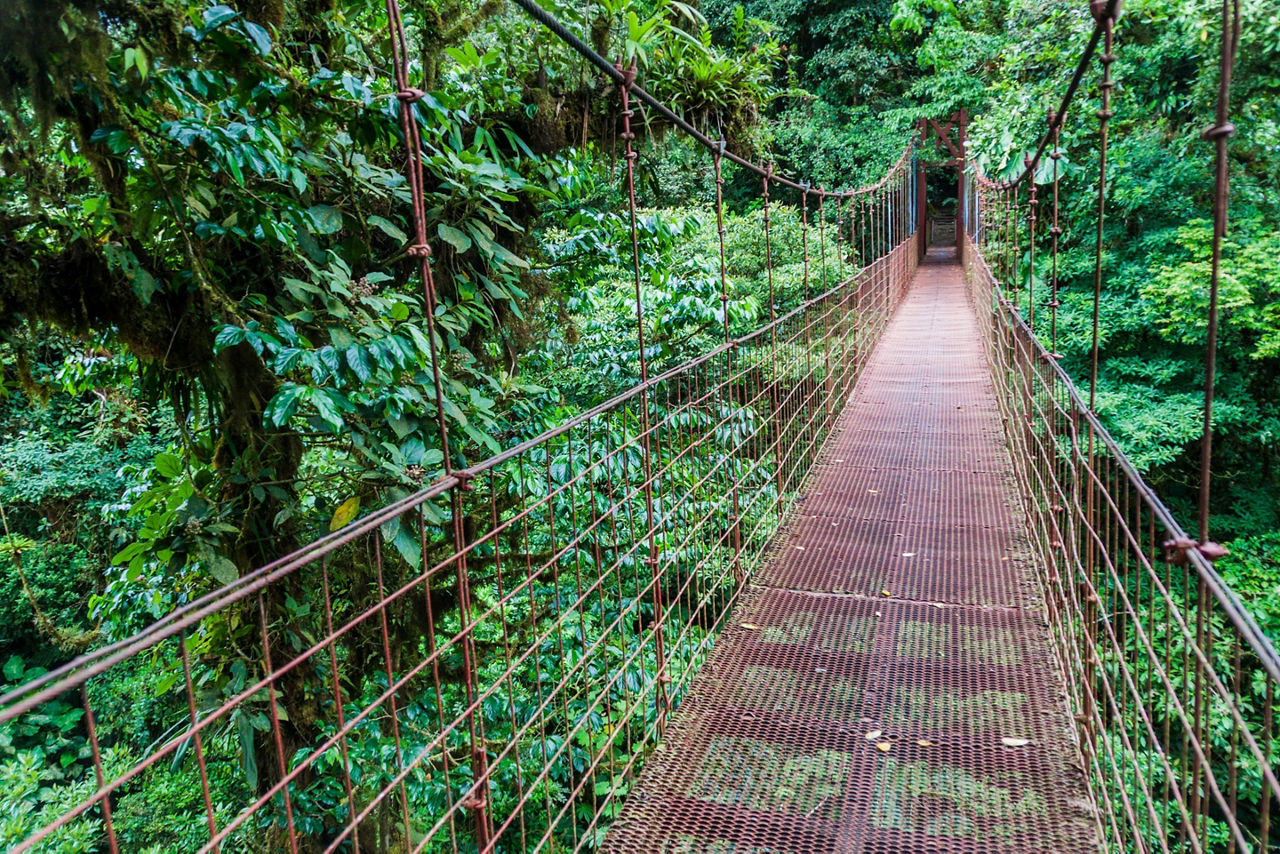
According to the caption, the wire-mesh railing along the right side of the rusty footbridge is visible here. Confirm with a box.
[960,224,1280,853]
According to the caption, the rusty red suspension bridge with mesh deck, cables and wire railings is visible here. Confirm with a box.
[0,0,1280,854]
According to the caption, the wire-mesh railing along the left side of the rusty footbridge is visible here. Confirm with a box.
[0,155,916,851]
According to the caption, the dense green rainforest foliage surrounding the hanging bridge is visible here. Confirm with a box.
[0,0,1280,851]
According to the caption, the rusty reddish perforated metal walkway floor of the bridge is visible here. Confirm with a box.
[603,250,1098,854]
